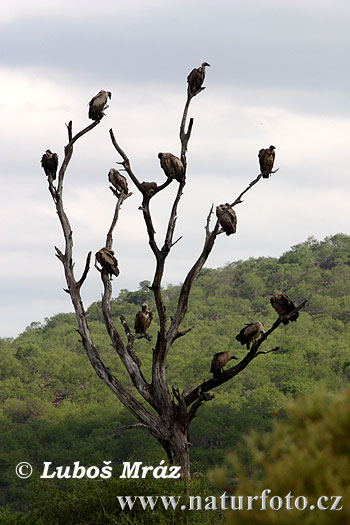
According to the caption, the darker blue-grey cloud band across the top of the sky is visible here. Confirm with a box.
[2,2,350,96]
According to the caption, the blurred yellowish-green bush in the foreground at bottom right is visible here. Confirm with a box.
[212,382,350,525]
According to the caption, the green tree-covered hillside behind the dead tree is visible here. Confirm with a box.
[0,234,350,523]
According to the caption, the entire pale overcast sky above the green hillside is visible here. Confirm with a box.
[0,0,350,337]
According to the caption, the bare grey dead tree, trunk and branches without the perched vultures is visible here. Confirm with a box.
[48,69,306,478]
